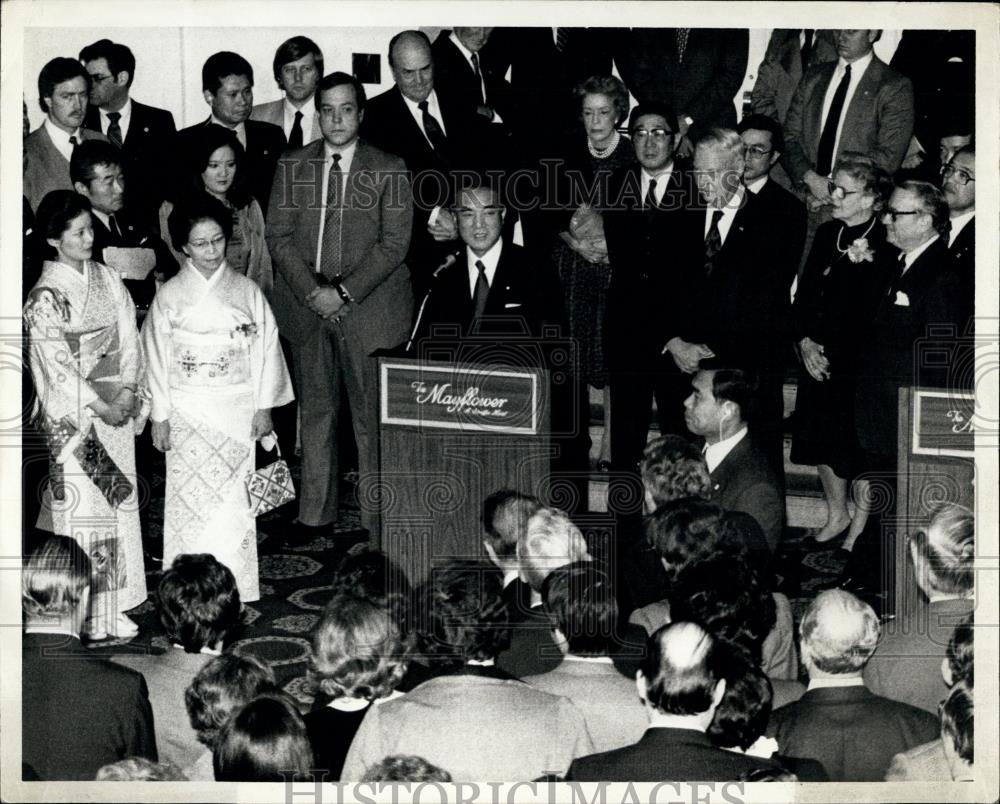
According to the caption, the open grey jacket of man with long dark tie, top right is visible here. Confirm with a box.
[785,56,914,182]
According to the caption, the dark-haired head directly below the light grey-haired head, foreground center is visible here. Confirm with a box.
[542,561,618,656]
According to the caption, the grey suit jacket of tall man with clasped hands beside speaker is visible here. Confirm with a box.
[265,140,413,354]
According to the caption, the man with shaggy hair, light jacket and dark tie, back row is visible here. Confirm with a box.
[250,36,323,149]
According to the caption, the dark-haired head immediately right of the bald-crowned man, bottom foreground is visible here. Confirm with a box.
[708,646,774,751]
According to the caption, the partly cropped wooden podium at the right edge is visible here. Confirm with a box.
[895,388,976,622]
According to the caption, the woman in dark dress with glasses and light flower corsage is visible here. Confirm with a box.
[791,153,898,549]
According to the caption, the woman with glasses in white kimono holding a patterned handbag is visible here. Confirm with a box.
[142,197,293,602]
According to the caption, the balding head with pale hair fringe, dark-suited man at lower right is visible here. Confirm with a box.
[800,589,881,678]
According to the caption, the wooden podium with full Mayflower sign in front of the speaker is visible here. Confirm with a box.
[370,356,552,584]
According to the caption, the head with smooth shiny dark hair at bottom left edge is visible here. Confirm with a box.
[212,693,313,782]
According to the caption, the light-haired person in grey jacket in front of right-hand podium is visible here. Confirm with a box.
[865,503,976,713]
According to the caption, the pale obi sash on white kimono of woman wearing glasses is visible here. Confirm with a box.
[170,330,250,390]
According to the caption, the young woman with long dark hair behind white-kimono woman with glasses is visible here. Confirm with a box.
[160,126,274,296]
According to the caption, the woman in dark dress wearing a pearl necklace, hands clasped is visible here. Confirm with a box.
[553,75,635,470]
